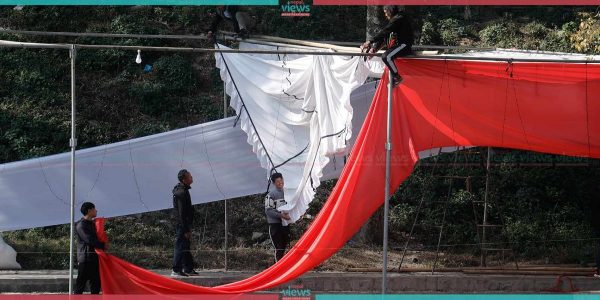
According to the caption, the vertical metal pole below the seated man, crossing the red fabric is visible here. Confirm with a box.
[381,70,392,294]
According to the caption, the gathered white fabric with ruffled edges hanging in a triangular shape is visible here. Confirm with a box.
[215,45,369,221]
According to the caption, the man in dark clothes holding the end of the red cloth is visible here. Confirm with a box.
[74,202,108,294]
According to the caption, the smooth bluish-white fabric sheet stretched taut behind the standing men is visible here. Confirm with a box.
[0,84,375,232]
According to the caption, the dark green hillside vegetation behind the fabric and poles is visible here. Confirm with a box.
[0,6,600,270]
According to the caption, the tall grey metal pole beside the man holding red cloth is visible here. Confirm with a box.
[69,45,77,295]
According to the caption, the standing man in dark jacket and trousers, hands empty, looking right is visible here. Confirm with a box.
[171,169,198,277]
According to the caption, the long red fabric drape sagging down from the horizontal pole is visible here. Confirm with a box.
[100,59,600,294]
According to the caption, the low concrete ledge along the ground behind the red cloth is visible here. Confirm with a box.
[0,270,600,294]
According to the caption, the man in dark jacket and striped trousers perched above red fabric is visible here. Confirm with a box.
[361,5,414,86]
